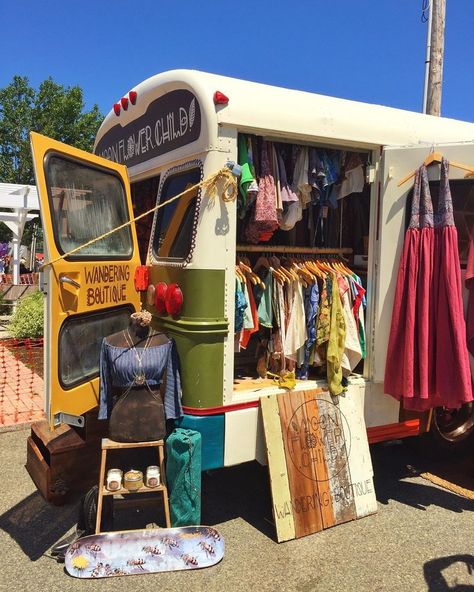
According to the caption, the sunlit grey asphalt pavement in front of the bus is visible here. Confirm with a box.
[0,430,474,592]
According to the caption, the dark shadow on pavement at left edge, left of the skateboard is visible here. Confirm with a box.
[0,491,77,561]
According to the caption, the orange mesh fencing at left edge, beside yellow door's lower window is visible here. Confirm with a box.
[0,338,44,427]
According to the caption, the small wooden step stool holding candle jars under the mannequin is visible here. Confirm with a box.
[95,438,171,534]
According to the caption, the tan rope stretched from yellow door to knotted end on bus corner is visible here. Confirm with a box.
[40,167,237,270]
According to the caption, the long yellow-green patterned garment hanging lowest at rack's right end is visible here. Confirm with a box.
[327,274,346,395]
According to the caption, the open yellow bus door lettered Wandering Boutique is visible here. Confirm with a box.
[31,133,140,426]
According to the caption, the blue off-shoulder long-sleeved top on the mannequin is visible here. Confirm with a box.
[99,338,183,419]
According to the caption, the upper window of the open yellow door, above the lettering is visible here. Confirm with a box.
[45,154,133,259]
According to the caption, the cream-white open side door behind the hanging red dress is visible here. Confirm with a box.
[371,142,474,382]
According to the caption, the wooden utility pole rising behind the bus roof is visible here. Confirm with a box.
[423,0,446,116]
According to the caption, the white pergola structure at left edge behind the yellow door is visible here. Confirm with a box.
[0,183,40,285]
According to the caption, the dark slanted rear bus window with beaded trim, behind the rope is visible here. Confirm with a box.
[153,168,201,260]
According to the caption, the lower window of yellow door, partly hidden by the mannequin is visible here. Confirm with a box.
[59,307,133,388]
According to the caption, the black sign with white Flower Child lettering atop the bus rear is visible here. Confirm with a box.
[95,89,201,167]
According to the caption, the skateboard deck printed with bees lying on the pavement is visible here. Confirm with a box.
[65,526,224,578]
